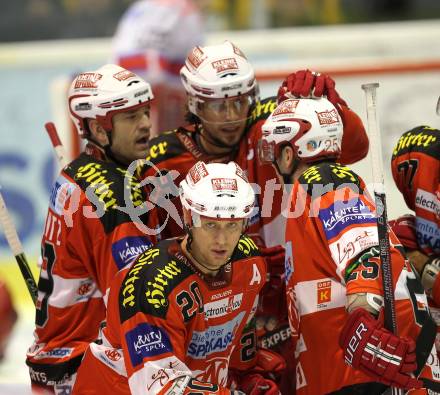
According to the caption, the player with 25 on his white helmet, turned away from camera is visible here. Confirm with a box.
[261,98,440,395]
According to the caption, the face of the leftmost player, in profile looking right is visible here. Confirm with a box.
[111,104,151,164]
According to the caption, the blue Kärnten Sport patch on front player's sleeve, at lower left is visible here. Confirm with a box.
[125,323,173,366]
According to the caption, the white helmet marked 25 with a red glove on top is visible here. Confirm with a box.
[260,98,343,162]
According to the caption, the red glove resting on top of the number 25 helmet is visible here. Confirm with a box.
[277,70,347,107]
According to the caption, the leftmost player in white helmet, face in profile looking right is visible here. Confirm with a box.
[26,65,159,394]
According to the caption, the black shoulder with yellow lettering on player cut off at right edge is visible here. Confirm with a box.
[392,126,440,159]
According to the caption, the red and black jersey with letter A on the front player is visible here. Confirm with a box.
[74,236,266,394]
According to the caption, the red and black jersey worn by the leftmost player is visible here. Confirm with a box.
[26,153,156,385]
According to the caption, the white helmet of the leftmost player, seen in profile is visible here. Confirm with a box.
[69,64,153,137]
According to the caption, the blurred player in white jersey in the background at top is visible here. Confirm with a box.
[112,0,204,136]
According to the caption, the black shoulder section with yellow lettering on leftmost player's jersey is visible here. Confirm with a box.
[64,154,146,233]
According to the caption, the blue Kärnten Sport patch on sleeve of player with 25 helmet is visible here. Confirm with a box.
[318,199,376,240]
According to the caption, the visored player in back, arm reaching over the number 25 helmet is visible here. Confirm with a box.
[146,41,368,394]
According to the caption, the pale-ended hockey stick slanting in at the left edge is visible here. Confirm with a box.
[0,193,38,305]
